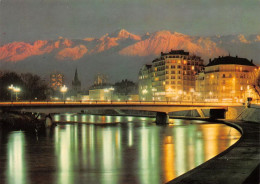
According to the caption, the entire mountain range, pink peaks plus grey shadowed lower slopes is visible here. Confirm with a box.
[0,29,260,85]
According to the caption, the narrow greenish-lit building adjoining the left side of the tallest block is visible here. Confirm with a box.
[138,64,153,101]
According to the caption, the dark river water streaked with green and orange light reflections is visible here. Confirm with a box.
[0,114,240,184]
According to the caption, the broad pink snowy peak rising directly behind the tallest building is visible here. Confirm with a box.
[119,31,227,58]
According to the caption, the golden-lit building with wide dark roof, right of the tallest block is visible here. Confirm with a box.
[196,56,259,102]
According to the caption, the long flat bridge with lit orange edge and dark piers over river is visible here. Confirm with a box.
[0,101,241,123]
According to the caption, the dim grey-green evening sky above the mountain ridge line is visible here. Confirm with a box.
[0,0,260,45]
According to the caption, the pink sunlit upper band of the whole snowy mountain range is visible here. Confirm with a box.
[0,29,260,62]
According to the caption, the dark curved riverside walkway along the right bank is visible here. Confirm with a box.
[168,121,260,184]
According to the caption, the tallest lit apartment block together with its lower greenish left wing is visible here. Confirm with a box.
[139,50,203,101]
